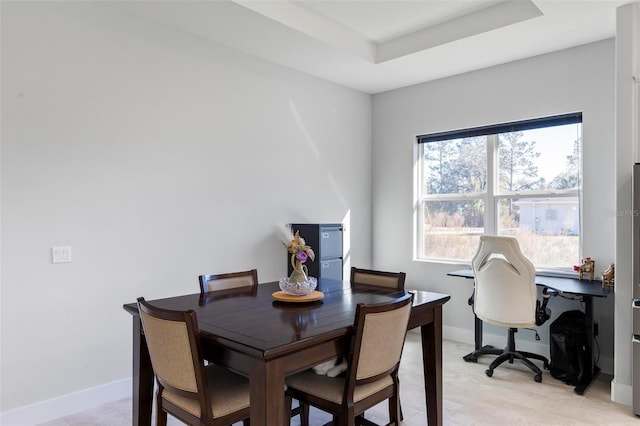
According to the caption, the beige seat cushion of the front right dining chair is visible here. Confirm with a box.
[286,370,393,404]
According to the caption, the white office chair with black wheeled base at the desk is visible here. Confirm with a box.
[465,235,549,382]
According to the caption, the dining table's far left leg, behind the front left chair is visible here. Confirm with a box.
[132,315,154,426]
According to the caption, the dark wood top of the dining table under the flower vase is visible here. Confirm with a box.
[124,279,449,359]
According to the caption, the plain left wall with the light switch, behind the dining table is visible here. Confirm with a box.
[0,2,372,413]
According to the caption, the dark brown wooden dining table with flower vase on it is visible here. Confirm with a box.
[124,278,450,426]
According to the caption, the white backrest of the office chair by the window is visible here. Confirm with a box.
[471,235,537,328]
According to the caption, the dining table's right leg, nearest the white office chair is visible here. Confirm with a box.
[422,305,442,426]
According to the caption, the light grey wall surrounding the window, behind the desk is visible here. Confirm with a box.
[373,40,616,382]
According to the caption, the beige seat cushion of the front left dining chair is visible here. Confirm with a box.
[163,365,249,417]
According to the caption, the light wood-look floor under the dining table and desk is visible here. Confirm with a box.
[38,333,640,426]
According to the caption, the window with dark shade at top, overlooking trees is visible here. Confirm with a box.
[416,113,582,269]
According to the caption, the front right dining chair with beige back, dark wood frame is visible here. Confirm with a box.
[285,293,413,426]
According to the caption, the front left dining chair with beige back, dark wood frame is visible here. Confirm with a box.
[138,297,250,426]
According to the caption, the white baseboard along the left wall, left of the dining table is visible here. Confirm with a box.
[0,378,133,426]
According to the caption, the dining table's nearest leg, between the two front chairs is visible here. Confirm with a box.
[249,360,284,426]
